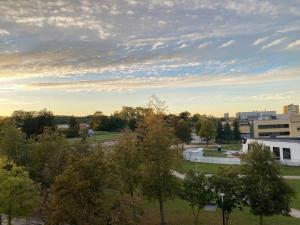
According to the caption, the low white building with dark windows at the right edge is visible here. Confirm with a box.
[243,138,300,166]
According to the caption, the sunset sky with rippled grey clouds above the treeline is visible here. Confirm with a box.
[0,0,300,116]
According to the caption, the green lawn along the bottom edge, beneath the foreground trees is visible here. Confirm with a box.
[140,199,300,225]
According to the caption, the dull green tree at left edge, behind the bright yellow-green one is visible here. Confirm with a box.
[0,121,28,166]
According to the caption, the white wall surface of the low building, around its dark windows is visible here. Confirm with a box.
[243,139,300,166]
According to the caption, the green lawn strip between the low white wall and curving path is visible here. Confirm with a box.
[174,156,300,176]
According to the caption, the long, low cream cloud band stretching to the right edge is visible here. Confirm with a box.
[23,68,300,92]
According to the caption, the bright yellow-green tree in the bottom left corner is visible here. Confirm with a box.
[0,158,39,225]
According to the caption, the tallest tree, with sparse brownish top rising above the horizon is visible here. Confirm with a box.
[139,97,178,225]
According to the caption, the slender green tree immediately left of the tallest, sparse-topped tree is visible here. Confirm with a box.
[113,130,142,222]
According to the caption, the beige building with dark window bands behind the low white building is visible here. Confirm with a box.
[252,115,300,138]
